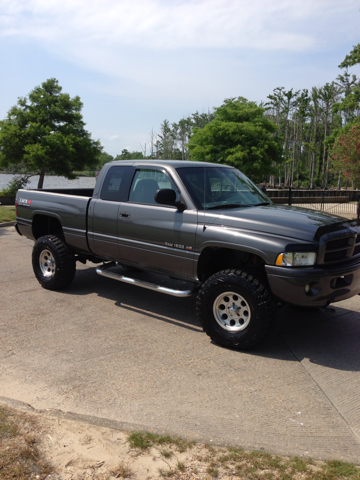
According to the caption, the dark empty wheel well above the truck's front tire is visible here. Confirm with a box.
[198,247,266,282]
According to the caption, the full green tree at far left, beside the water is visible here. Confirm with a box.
[0,78,102,188]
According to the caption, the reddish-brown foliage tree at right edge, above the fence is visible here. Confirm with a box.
[331,123,360,184]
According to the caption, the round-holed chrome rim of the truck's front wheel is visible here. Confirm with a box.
[213,292,251,333]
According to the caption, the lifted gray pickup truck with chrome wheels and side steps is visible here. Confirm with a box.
[16,160,360,349]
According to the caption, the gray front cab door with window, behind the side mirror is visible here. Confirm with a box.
[118,168,197,278]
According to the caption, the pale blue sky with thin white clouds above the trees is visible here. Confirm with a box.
[0,0,360,156]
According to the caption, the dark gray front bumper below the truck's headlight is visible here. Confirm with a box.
[265,259,360,307]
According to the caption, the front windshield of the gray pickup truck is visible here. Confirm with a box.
[176,165,271,210]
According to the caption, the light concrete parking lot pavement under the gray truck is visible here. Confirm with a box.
[0,228,360,463]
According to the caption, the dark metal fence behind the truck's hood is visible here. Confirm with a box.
[266,188,360,220]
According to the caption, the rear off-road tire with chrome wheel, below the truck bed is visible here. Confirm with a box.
[32,235,76,290]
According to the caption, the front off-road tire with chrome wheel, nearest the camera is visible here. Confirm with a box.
[196,270,276,350]
